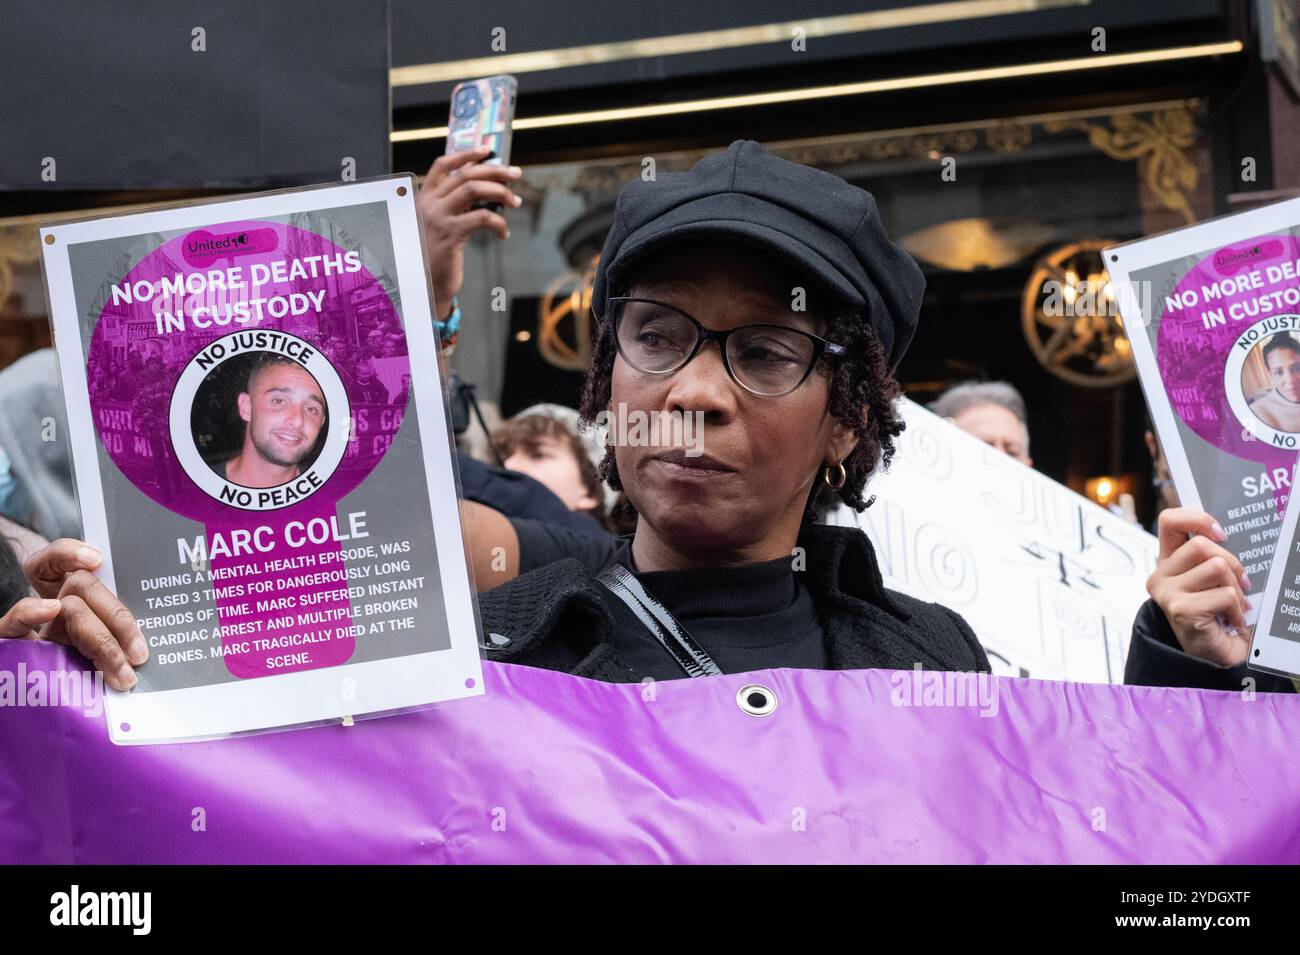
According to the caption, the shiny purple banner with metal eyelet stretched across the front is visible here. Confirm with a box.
[0,641,1300,863]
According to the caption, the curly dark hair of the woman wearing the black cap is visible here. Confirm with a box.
[579,302,905,524]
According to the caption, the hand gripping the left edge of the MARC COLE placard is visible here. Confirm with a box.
[9,538,150,690]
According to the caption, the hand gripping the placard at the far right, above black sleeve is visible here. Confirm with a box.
[1147,507,1251,667]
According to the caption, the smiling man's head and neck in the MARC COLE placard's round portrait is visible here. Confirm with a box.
[213,353,328,487]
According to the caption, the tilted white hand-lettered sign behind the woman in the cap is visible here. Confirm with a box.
[827,399,1158,683]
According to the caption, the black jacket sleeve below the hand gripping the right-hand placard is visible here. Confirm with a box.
[1125,600,1295,693]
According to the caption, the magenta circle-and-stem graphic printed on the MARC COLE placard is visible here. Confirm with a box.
[86,221,411,678]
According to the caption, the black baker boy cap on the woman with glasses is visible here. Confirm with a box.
[592,140,926,368]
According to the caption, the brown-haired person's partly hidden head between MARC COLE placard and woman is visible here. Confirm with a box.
[491,409,605,522]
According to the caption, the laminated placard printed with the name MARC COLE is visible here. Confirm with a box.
[40,177,482,743]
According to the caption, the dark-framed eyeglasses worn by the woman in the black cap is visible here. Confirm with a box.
[606,296,848,398]
